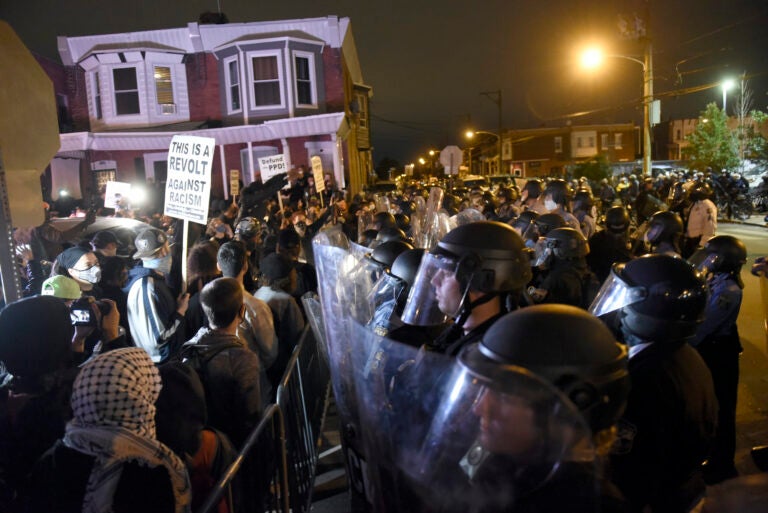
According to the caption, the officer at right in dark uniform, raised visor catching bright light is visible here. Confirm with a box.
[590,255,717,512]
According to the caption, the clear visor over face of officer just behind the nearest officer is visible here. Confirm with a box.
[402,253,469,326]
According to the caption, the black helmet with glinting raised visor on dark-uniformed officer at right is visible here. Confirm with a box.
[589,255,708,341]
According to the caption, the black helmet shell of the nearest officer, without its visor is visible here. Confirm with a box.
[459,304,630,433]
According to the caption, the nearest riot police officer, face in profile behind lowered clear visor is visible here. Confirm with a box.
[406,305,629,512]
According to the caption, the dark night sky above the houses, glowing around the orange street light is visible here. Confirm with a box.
[0,0,768,163]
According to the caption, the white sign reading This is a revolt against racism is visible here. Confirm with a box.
[165,135,216,224]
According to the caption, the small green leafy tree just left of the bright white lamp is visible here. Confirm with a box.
[683,103,739,172]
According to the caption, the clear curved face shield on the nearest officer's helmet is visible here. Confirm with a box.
[402,356,592,500]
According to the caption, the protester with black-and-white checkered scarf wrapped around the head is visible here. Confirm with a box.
[29,348,191,513]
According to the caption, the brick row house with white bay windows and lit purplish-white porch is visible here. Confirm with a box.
[43,16,373,208]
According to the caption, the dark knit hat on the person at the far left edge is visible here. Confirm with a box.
[0,296,73,378]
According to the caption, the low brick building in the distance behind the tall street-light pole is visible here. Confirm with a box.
[501,123,640,177]
